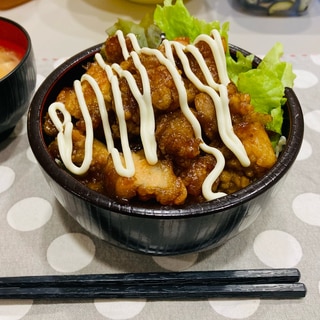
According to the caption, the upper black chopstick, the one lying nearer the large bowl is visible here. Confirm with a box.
[0,268,300,288]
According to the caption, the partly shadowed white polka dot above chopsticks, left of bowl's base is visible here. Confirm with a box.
[47,233,96,272]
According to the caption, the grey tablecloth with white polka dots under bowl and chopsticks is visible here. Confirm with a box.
[0,55,320,320]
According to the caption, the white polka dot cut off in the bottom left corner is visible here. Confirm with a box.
[0,300,33,320]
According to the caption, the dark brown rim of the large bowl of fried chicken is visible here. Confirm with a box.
[27,43,304,219]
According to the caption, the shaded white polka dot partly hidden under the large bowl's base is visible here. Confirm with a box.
[152,253,198,271]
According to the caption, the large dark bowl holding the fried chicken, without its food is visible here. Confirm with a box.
[28,45,303,255]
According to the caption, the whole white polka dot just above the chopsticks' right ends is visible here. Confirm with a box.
[253,230,302,268]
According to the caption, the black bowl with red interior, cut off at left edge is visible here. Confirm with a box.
[0,17,37,141]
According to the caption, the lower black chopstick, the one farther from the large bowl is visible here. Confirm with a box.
[0,282,306,300]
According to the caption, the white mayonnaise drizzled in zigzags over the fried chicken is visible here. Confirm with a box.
[49,30,250,200]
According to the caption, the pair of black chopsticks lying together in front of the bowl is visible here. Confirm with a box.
[0,268,306,300]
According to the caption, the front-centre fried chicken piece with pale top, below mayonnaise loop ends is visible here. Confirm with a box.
[105,151,187,205]
